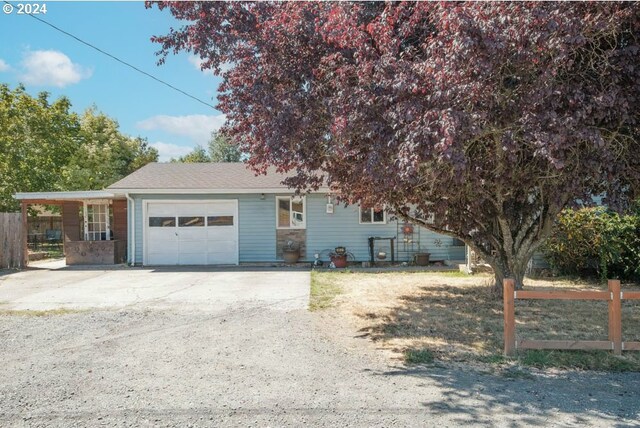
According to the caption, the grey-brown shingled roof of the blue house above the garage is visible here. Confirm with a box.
[106,162,300,192]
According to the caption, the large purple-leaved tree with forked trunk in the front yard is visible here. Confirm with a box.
[147,2,640,288]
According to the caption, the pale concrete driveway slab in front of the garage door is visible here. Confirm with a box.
[0,261,310,311]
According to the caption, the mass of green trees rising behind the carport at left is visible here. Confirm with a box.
[0,84,158,211]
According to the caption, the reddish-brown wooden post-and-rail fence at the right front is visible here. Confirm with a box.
[504,279,640,355]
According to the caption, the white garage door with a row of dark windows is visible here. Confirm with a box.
[144,200,238,265]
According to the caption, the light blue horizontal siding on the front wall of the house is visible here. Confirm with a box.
[130,193,465,264]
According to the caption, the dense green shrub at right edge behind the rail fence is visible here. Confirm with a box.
[543,207,640,280]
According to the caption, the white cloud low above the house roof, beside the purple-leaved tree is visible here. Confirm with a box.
[136,114,225,146]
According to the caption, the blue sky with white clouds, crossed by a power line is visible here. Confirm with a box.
[0,1,224,161]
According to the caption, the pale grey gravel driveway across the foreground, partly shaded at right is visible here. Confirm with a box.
[0,266,640,427]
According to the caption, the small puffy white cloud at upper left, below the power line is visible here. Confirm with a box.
[20,50,92,88]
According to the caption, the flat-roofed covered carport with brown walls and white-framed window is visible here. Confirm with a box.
[14,190,127,265]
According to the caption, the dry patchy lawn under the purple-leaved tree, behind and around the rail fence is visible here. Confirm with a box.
[312,272,640,371]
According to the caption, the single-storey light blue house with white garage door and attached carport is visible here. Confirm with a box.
[16,163,465,265]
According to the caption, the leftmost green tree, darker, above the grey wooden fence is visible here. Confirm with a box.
[0,84,80,211]
